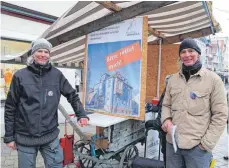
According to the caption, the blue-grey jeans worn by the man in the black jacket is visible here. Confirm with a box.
[17,138,63,168]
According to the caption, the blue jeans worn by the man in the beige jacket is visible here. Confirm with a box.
[166,142,212,168]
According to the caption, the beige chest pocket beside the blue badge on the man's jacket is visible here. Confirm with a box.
[189,91,209,115]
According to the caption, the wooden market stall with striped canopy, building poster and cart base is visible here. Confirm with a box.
[0,1,220,168]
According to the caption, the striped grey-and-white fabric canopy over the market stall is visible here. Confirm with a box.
[1,1,220,66]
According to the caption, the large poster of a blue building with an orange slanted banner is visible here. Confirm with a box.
[84,17,148,120]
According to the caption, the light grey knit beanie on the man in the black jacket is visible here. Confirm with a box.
[31,38,52,54]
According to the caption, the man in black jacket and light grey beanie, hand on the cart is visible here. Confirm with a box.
[4,39,89,168]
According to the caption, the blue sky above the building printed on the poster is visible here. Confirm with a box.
[88,40,141,94]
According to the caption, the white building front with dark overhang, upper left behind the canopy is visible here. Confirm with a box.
[1,2,57,60]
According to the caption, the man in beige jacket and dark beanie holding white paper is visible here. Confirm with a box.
[161,38,228,168]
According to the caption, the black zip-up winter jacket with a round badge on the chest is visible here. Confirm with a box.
[4,64,86,143]
